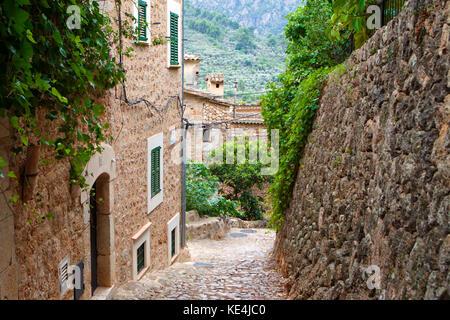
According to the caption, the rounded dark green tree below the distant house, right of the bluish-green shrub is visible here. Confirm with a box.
[210,139,272,220]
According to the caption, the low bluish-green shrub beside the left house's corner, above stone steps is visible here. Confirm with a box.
[186,164,244,218]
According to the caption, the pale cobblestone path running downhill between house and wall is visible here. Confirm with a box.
[112,229,285,300]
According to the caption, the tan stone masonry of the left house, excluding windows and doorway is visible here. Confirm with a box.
[0,0,182,299]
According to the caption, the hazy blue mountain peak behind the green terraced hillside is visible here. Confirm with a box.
[186,0,304,35]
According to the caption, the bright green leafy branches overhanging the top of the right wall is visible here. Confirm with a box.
[328,0,376,49]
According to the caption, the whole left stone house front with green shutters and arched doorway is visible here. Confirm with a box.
[0,0,182,299]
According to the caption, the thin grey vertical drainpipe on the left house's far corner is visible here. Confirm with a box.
[181,0,186,248]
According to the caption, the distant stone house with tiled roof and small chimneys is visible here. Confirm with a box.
[184,55,266,162]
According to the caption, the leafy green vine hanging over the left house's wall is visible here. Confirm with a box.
[0,0,132,189]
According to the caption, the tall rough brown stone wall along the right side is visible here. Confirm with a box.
[276,0,450,299]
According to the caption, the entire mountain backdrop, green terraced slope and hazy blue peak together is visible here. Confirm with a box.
[184,0,302,103]
